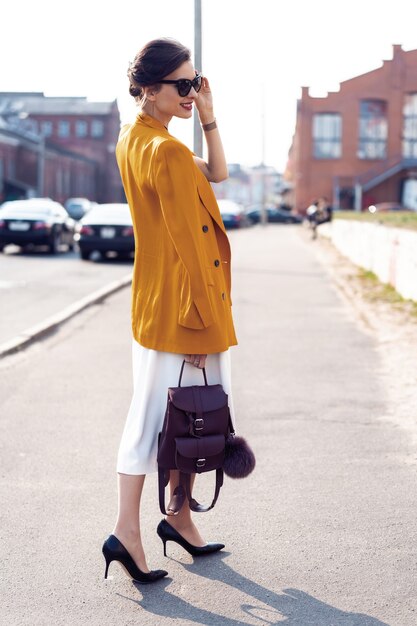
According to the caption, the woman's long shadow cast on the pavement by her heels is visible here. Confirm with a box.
[114,552,389,626]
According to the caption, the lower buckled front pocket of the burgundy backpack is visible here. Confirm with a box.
[175,435,226,474]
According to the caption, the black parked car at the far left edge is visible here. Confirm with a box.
[0,198,75,254]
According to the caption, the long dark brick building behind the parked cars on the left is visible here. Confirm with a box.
[0,92,124,202]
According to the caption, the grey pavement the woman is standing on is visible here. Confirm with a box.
[0,225,417,626]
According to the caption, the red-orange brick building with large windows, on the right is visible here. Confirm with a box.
[285,45,417,212]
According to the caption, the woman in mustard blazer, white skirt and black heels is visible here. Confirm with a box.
[103,39,237,582]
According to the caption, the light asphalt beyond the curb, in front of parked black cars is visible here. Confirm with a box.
[0,246,132,345]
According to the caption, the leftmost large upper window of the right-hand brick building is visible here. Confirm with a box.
[313,113,342,159]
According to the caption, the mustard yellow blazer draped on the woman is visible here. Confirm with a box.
[116,113,237,354]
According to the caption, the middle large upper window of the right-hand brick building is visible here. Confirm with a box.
[358,100,388,159]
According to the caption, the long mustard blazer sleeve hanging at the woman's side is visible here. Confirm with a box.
[154,140,214,329]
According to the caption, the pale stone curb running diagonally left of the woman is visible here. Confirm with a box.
[0,274,132,359]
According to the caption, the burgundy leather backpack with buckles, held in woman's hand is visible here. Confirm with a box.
[157,361,233,515]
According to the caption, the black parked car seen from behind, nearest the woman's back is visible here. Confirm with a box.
[75,204,135,260]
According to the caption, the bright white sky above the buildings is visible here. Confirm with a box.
[0,0,417,171]
